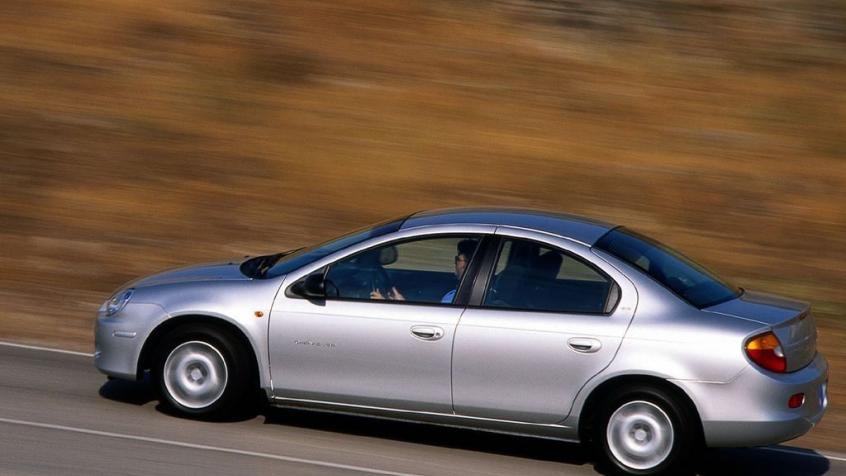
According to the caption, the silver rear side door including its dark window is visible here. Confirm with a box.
[453,229,637,424]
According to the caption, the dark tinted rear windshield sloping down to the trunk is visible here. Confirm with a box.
[594,228,740,309]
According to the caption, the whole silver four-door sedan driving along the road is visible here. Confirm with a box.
[95,209,828,475]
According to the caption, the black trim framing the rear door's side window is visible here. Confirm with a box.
[467,235,623,316]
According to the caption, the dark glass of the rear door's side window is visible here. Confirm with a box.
[484,239,619,314]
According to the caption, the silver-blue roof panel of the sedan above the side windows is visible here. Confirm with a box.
[400,208,615,246]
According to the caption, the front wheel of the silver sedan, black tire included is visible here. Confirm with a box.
[153,324,258,419]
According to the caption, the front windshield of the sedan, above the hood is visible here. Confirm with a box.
[241,217,405,279]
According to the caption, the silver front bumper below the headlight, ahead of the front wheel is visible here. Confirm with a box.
[94,303,167,380]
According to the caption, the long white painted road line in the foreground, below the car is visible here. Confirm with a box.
[0,418,419,476]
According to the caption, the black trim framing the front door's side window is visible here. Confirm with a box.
[285,231,495,308]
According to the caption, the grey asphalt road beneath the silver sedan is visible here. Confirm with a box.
[0,344,846,476]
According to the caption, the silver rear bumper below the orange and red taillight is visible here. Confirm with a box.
[674,354,828,447]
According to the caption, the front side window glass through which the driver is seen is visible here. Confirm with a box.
[326,235,480,304]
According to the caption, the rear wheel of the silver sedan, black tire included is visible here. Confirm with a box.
[591,385,702,476]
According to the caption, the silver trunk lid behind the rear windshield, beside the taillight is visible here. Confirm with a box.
[704,291,817,372]
